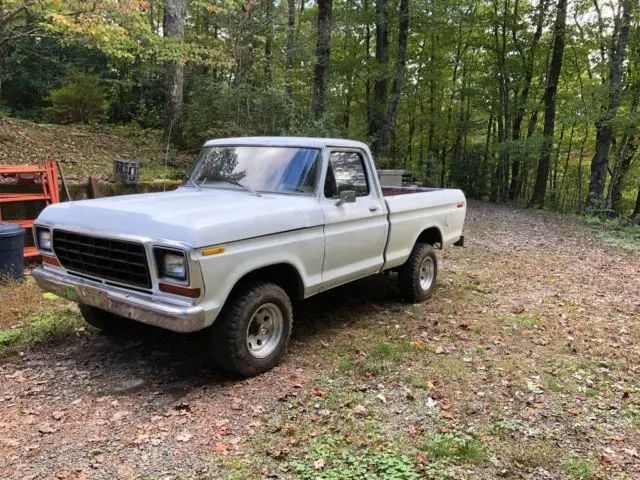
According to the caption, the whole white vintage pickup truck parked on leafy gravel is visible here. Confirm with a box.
[33,137,466,376]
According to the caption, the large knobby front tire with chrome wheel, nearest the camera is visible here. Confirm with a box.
[209,282,293,377]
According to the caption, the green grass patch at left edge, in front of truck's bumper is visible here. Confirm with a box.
[0,306,83,355]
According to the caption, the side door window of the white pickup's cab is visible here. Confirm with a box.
[324,152,369,198]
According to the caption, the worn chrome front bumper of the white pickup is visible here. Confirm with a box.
[32,267,207,332]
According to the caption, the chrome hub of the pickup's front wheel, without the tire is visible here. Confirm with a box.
[246,303,284,358]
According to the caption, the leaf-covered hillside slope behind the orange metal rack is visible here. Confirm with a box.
[0,116,195,182]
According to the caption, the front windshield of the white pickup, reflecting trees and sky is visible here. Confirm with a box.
[187,146,319,195]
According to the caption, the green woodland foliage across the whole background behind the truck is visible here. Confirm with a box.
[0,0,640,215]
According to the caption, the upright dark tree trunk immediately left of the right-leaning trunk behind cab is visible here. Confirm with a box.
[369,0,389,154]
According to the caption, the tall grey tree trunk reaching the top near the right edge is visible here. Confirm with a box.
[586,0,631,213]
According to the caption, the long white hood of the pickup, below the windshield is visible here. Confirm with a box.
[36,188,324,248]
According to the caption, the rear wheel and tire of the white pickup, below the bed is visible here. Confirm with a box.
[398,243,438,303]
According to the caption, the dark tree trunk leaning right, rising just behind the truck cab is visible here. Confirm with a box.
[378,0,409,157]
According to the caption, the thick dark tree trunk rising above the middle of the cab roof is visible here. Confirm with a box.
[311,0,333,120]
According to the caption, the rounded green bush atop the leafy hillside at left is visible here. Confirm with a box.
[44,72,109,124]
